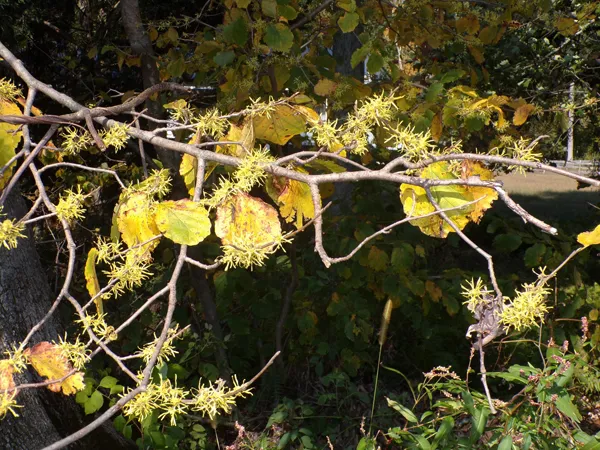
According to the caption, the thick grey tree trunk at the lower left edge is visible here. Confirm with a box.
[0,190,137,450]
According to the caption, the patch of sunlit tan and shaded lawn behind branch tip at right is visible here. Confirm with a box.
[498,172,600,224]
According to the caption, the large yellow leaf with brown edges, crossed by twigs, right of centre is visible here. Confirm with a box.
[400,162,497,238]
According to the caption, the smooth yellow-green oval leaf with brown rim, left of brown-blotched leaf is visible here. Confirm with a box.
[154,199,211,245]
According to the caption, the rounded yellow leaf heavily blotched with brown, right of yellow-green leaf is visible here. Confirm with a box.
[215,193,281,247]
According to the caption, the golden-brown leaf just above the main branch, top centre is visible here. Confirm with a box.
[253,105,319,145]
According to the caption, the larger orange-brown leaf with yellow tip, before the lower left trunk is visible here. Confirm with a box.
[25,342,85,395]
